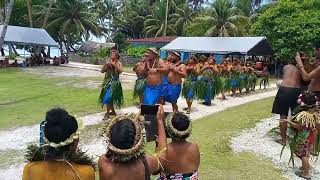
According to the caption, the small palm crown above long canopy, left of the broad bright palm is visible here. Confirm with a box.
[172,4,197,36]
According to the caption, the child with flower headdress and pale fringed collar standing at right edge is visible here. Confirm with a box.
[281,92,320,179]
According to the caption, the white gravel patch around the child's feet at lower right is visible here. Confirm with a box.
[231,116,320,180]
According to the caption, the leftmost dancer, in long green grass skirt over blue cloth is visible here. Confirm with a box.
[99,50,123,119]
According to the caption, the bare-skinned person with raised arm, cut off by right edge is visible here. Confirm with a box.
[296,47,320,97]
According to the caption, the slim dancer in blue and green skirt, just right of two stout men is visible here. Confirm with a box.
[182,55,198,114]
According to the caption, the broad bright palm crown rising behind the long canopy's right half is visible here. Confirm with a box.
[195,0,249,36]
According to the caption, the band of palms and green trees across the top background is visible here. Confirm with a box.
[0,0,320,59]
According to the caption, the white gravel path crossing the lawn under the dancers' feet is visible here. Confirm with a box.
[0,90,276,179]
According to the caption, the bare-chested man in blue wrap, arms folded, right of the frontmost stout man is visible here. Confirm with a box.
[164,52,187,112]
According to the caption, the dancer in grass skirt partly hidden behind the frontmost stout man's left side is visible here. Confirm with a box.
[133,54,148,105]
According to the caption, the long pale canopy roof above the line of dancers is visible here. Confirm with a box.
[161,37,272,55]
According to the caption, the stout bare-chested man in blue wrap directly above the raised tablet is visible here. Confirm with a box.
[143,48,168,105]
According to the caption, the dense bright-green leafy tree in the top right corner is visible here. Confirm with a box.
[251,0,320,60]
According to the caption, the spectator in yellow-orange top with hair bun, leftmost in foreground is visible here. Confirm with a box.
[22,108,95,180]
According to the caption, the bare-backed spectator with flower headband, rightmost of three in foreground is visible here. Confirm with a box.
[159,112,200,180]
